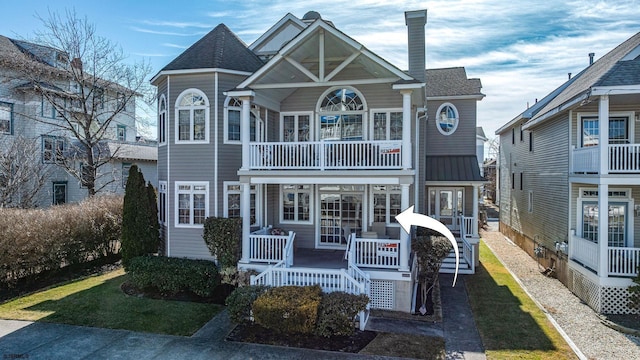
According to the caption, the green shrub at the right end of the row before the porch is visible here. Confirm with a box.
[316,291,369,337]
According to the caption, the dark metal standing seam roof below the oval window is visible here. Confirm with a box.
[425,155,486,182]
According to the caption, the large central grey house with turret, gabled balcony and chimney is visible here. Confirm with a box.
[152,10,484,312]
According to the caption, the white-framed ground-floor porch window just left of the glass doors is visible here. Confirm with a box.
[280,185,313,224]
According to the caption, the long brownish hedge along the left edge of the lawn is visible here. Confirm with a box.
[0,196,122,287]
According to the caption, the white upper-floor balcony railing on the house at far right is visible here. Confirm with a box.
[571,144,640,174]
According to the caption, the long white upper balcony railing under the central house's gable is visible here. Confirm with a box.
[249,141,402,170]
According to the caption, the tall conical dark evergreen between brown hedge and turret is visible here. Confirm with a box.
[121,165,159,269]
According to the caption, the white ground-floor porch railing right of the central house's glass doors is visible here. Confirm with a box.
[349,238,400,270]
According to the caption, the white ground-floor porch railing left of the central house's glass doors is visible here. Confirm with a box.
[249,227,296,266]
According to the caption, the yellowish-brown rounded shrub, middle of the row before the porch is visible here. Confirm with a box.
[252,285,322,334]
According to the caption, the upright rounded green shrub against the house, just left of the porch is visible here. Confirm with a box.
[202,217,242,269]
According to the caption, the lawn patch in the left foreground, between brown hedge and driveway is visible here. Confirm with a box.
[0,270,222,336]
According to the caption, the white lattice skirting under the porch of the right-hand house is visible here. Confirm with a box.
[569,270,640,314]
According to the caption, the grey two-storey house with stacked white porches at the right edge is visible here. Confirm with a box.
[496,33,640,313]
